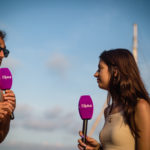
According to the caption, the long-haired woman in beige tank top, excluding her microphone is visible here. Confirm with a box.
[78,49,150,150]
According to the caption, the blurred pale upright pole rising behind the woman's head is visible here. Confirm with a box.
[133,24,138,63]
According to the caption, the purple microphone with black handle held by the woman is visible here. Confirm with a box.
[79,95,94,146]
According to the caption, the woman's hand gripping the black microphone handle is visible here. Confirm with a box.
[78,131,100,150]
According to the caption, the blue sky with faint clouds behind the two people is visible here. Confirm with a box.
[0,0,150,150]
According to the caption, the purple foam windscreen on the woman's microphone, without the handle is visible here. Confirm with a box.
[79,95,94,120]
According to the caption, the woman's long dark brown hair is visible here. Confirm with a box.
[99,49,150,136]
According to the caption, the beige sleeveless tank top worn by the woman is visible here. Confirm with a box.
[99,111,135,150]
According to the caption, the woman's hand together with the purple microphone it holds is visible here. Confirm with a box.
[78,95,100,150]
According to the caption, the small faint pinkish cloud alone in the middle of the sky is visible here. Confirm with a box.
[47,53,70,76]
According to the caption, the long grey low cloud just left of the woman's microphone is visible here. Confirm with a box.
[22,109,79,134]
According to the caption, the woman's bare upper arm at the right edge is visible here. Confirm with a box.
[135,99,150,150]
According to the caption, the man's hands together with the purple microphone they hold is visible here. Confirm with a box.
[0,68,16,120]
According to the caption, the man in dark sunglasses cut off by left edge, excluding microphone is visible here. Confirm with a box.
[0,30,16,143]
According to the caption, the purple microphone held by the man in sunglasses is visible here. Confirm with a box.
[0,68,14,119]
